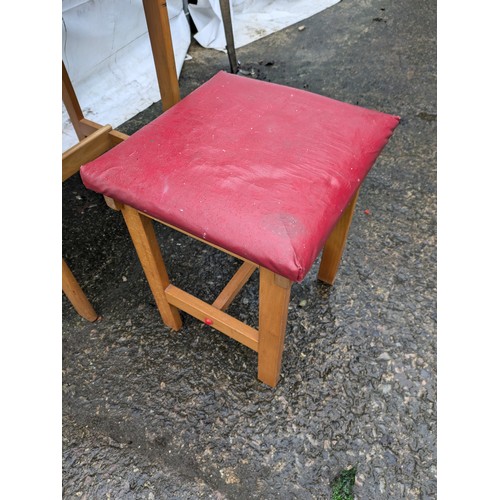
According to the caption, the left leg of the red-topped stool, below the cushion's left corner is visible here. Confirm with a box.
[121,205,182,330]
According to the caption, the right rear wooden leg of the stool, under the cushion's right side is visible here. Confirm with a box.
[318,189,359,285]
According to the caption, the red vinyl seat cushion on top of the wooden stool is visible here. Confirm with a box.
[80,72,399,281]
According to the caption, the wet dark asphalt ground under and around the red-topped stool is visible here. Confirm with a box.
[62,0,437,499]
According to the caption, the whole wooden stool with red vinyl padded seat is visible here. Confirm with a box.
[81,72,399,387]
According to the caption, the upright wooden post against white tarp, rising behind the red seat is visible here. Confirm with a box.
[142,0,180,111]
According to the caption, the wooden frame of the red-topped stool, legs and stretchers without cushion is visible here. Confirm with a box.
[104,191,358,387]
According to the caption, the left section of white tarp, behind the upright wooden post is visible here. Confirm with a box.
[62,0,191,151]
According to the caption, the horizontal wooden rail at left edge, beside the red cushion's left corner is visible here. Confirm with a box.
[62,125,113,182]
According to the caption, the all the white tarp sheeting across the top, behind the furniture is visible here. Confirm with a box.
[62,0,340,151]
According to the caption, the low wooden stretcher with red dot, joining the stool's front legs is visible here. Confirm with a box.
[165,285,259,351]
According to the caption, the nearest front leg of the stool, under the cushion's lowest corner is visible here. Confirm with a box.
[258,267,292,387]
